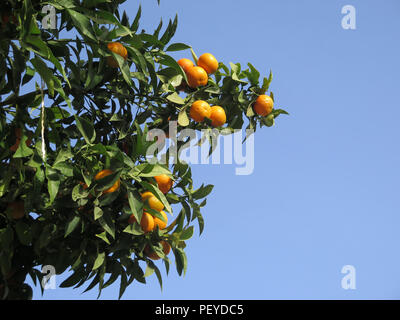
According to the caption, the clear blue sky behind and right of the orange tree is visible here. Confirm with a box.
[29,0,400,299]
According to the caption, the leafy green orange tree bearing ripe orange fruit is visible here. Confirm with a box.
[0,0,286,299]
